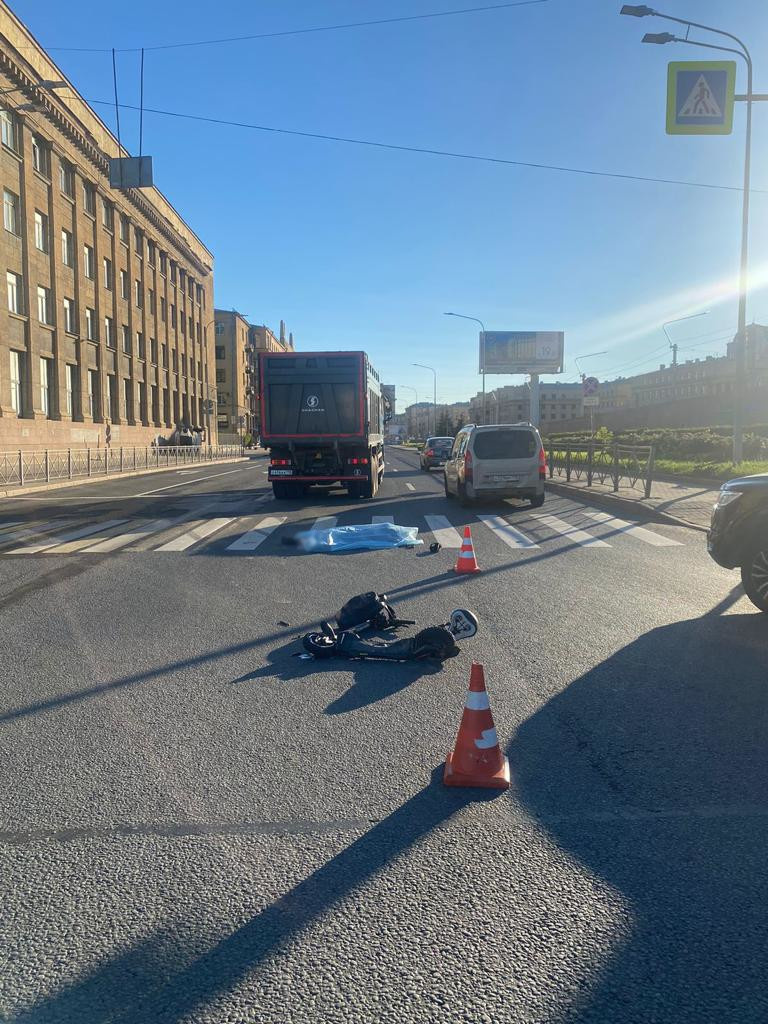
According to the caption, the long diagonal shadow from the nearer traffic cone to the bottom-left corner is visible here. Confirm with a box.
[6,765,499,1024]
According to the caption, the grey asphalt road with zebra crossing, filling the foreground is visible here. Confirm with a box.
[0,450,768,1024]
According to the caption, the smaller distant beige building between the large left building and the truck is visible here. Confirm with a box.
[214,309,293,441]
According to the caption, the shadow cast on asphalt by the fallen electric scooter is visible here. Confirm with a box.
[232,633,442,715]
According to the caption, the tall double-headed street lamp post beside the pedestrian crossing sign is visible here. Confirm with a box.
[621,4,768,465]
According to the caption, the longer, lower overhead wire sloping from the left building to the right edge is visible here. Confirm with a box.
[90,99,768,194]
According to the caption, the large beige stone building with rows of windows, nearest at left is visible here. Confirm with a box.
[0,2,216,450]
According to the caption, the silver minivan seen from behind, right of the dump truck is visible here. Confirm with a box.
[444,423,547,508]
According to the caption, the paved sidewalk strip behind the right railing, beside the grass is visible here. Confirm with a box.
[547,474,719,529]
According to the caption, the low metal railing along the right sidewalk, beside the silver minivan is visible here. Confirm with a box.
[547,441,655,498]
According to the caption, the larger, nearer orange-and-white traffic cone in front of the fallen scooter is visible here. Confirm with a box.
[442,662,509,790]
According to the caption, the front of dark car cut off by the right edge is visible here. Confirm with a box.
[707,473,768,612]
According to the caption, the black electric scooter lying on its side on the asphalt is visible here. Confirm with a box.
[302,591,478,662]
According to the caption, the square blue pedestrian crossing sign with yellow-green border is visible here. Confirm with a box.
[667,60,736,135]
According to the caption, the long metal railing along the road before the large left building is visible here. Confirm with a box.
[0,444,243,487]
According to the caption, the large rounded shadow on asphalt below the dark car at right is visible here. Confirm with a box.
[508,588,768,1024]
